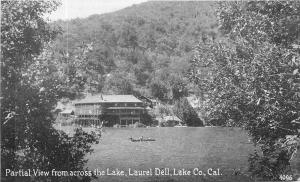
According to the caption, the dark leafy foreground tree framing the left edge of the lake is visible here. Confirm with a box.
[1,1,97,181]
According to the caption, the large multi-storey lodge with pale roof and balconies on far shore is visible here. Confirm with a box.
[75,94,146,126]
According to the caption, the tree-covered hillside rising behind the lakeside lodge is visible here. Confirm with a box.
[55,1,218,100]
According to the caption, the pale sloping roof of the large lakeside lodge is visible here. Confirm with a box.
[75,94,142,104]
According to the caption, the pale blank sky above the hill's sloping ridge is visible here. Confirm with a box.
[48,0,147,21]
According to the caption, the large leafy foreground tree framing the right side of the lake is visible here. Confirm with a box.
[190,1,300,180]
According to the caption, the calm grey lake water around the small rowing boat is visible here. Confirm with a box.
[72,127,254,182]
